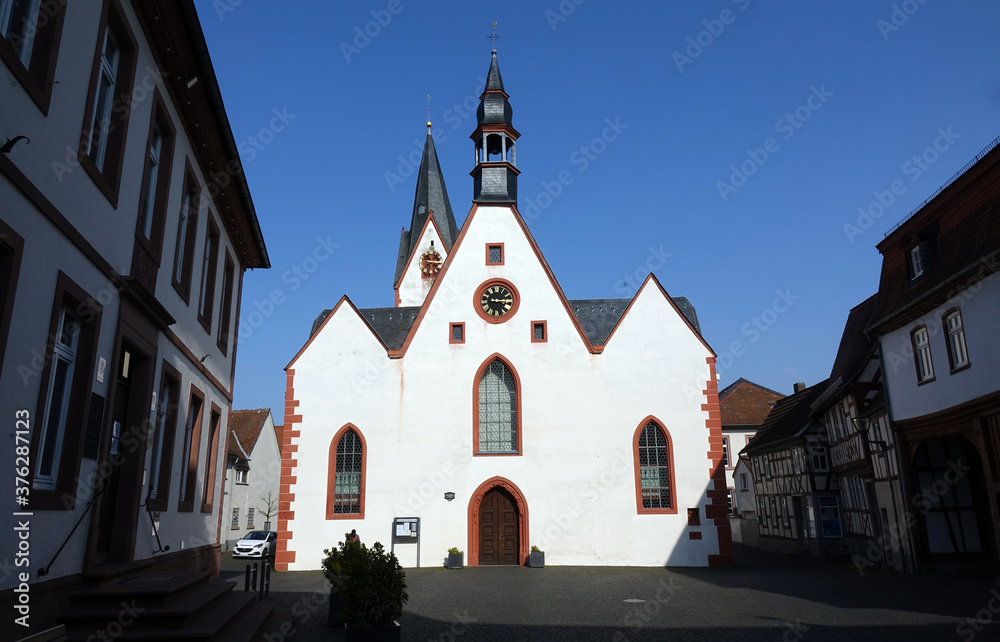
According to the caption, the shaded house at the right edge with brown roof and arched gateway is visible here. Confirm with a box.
[869,134,1000,572]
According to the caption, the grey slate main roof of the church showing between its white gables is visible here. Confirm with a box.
[309,297,701,350]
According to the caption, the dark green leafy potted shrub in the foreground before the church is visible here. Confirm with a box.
[323,537,409,642]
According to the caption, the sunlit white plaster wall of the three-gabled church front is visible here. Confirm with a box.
[289,207,718,569]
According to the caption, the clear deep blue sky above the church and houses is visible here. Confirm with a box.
[196,0,1000,423]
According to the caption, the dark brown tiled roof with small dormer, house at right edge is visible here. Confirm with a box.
[872,139,1000,332]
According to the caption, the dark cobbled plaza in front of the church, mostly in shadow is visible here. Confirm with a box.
[222,547,1000,642]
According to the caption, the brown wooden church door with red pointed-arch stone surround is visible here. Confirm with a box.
[468,477,528,566]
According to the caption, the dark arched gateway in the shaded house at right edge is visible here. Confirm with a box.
[913,435,993,562]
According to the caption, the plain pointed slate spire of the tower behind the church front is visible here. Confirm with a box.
[393,121,458,286]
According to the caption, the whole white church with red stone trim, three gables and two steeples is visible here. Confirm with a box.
[275,50,732,570]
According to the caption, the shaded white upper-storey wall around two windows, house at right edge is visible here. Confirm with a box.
[880,273,1000,421]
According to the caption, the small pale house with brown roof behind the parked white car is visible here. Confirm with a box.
[222,408,281,552]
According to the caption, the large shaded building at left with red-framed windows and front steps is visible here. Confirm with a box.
[0,0,269,639]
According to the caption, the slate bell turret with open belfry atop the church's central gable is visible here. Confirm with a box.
[470,49,521,205]
